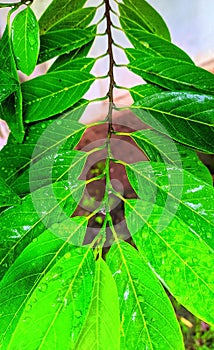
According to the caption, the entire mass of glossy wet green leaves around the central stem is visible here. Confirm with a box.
[0,0,214,350]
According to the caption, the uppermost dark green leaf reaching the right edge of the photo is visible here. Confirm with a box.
[128,55,214,94]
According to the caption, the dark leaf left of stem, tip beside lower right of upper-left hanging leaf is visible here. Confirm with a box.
[38,29,95,63]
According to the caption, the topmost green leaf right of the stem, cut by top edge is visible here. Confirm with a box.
[119,0,170,41]
